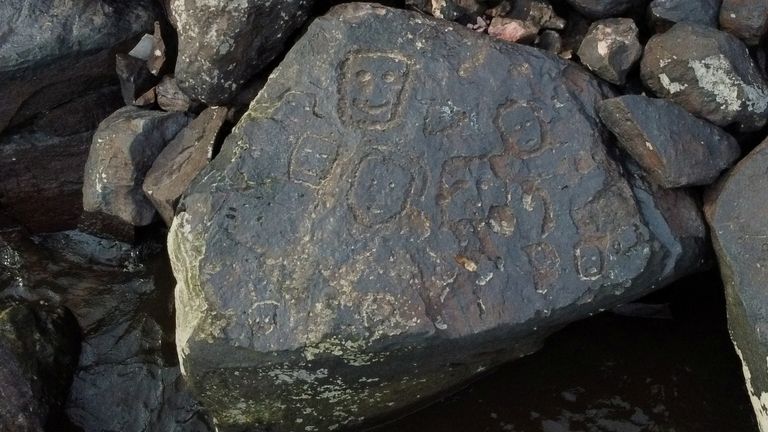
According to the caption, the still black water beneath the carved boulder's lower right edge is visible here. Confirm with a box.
[376,273,758,432]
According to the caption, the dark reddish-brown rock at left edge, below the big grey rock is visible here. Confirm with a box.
[0,87,122,232]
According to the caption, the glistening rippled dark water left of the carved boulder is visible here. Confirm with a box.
[0,230,212,432]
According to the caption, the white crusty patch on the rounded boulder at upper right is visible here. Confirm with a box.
[690,54,768,112]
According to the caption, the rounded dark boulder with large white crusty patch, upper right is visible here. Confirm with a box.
[640,23,768,131]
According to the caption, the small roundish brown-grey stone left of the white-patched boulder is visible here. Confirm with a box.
[578,18,643,84]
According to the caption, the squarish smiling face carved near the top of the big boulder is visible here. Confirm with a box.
[339,53,408,128]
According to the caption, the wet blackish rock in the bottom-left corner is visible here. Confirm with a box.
[0,296,79,432]
